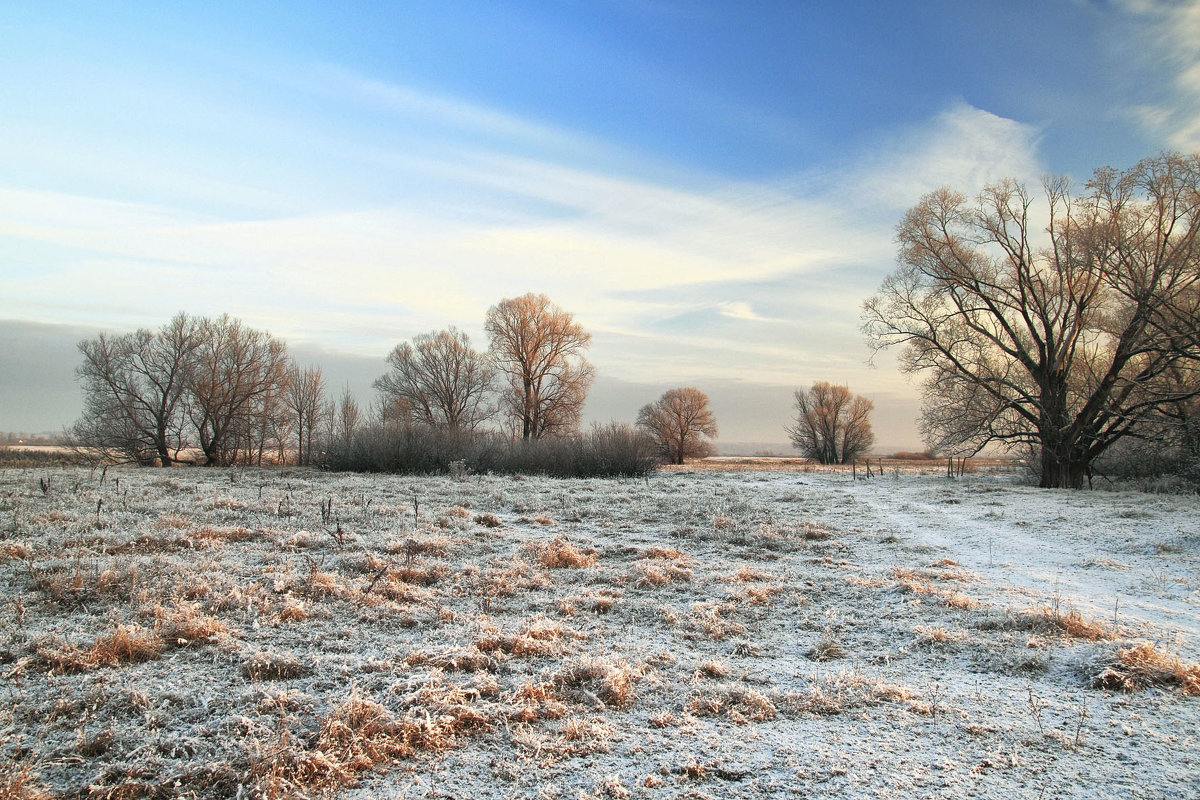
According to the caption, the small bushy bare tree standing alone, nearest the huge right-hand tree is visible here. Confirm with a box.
[786,380,875,464]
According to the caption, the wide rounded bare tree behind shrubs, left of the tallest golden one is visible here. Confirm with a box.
[374,327,496,429]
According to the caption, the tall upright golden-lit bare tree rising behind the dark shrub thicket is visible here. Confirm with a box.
[484,293,594,440]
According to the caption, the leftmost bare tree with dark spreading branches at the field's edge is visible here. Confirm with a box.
[71,312,198,467]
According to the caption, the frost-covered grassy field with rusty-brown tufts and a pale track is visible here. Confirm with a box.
[0,463,1200,799]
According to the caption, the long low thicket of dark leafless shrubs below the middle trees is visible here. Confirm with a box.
[319,423,656,477]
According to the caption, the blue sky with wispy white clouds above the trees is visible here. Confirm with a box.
[0,0,1200,447]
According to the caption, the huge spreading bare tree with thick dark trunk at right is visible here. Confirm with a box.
[863,154,1200,488]
